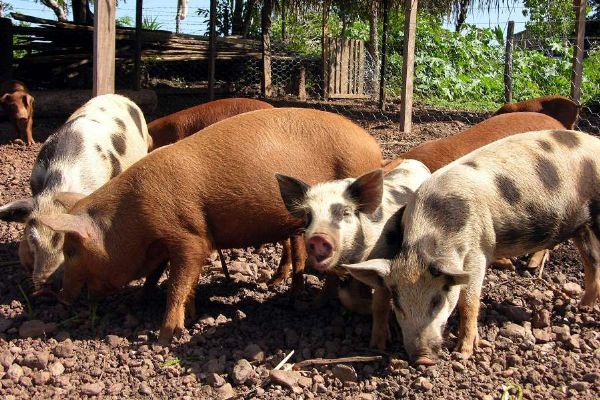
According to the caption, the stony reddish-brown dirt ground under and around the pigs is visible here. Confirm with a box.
[0,97,600,400]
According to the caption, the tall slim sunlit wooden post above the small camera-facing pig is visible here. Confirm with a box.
[400,0,418,133]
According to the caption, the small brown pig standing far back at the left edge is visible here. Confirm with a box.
[0,80,35,146]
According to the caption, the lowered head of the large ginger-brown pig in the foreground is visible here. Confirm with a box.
[38,213,112,304]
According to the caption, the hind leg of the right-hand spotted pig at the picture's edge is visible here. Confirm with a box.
[573,226,600,307]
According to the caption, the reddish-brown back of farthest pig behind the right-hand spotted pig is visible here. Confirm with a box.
[494,96,580,129]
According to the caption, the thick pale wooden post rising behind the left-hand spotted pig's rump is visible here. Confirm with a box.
[92,0,115,96]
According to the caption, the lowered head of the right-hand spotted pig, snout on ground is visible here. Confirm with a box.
[343,250,469,365]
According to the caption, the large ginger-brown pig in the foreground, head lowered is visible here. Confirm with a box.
[38,108,382,343]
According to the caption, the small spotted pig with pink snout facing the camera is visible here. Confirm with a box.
[277,160,431,347]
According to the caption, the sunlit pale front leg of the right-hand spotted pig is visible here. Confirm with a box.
[456,261,485,358]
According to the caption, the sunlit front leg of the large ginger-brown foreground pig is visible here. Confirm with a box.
[158,237,211,344]
